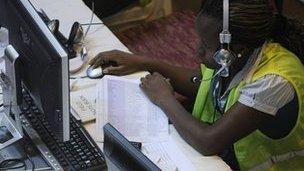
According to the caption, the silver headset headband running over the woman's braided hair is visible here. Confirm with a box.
[220,0,231,44]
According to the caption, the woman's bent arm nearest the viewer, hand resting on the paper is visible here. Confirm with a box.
[141,74,273,155]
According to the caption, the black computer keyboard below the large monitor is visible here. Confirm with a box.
[21,93,106,171]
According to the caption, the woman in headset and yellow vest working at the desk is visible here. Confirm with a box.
[91,0,304,170]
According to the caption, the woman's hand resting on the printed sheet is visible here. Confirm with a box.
[140,73,174,106]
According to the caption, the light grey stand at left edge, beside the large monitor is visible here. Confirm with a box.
[0,45,23,150]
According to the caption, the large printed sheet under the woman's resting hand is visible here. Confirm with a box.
[96,76,169,142]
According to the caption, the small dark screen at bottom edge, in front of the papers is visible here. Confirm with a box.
[103,123,160,171]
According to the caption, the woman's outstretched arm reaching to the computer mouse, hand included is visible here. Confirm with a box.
[90,50,201,99]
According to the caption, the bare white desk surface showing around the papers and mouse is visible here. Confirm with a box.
[31,0,230,170]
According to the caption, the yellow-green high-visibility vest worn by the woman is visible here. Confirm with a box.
[193,43,304,171]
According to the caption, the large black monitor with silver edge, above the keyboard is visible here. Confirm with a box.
[0,0,70,141]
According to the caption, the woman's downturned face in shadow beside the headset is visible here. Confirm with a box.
[196,14,221,69]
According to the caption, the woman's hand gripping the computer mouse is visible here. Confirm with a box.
[89,50,147,75]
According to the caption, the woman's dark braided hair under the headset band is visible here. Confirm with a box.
[203,0,304,63]
